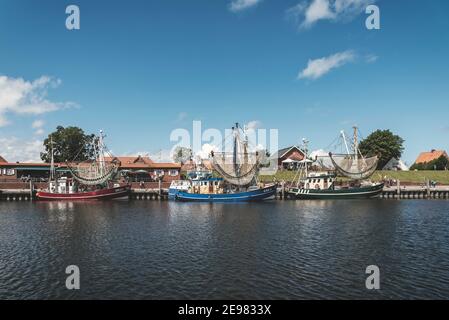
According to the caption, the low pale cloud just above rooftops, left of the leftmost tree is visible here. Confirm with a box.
[0,137,44,162]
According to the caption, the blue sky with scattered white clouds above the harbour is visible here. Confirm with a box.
[0,0,449,164]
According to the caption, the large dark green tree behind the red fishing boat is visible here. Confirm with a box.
[41,126,98,163]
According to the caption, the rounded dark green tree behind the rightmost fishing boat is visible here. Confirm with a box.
[359,130,404,169]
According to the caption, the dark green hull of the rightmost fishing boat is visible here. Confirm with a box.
[287,183,384,200]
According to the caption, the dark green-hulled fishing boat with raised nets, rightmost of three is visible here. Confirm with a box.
[287,127,384,200]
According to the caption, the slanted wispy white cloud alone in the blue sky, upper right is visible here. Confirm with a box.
[298,51,355,80]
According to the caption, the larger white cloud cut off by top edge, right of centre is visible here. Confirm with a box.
[287,0,376,29]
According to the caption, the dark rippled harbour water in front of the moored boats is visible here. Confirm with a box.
[0,200,449,299]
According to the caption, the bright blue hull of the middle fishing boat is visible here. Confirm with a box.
[169,185,276,202]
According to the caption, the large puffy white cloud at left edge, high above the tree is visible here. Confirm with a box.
[0,76,75,127]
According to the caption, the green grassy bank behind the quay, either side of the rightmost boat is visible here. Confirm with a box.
[259,171,449,184]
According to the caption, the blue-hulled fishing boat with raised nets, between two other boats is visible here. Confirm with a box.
[169,123,277,202]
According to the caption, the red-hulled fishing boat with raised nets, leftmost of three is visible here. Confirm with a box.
[36,131,131,201]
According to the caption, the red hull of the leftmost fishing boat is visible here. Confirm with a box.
[36,186,131,201]
